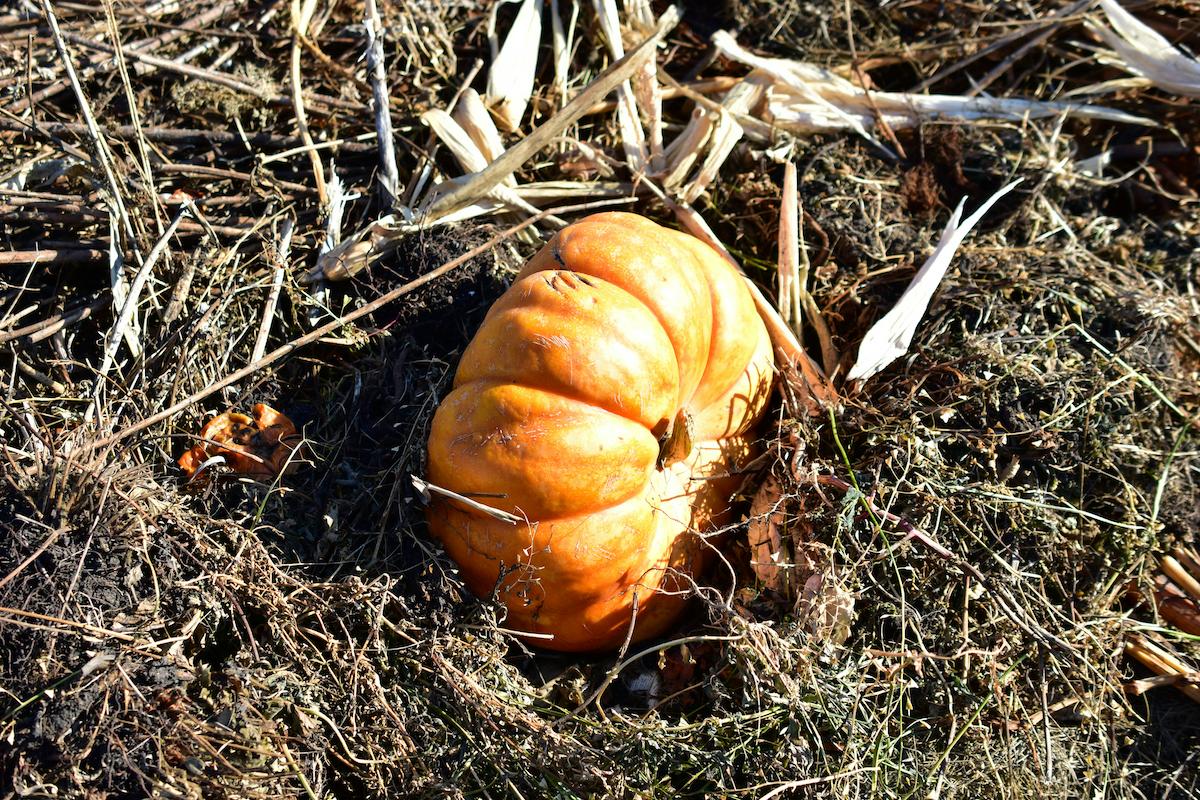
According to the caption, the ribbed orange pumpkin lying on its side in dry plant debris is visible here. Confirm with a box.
[427,213,774,651]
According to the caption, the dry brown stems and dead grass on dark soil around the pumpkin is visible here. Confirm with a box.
[0,0,1200,798]
